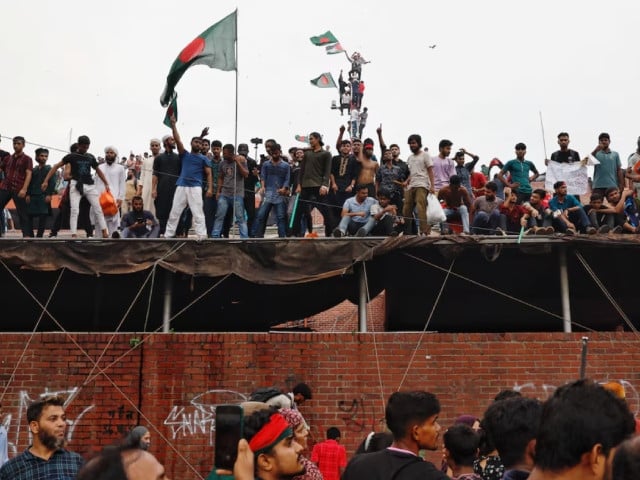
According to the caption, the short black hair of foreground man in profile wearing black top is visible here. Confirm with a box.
[384,390,440,440]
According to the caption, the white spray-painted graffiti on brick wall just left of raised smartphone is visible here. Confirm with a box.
[164,390,247,445]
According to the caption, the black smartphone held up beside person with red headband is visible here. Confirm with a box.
[213,405,243,470]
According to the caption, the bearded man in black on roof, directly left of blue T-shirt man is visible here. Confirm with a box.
[151,135,180,237]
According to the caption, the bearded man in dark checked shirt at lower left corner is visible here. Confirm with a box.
[0,396,83,480]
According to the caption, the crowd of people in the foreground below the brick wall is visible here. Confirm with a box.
[0,380,640,480]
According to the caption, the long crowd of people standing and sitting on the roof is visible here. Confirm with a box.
[0,128,640,239]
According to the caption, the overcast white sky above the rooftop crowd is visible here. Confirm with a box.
[0,0,640,174]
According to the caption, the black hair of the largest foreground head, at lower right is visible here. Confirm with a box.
[535,380,635,471]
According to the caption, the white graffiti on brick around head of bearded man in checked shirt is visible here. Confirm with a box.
[2,387,95,454]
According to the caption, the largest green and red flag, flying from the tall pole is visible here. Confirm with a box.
[160,11,237,107]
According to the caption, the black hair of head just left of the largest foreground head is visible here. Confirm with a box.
[483,397,542,468]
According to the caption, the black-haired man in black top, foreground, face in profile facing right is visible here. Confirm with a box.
[342,392,449,480]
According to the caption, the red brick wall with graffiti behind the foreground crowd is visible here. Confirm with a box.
[0,332,640,478]
